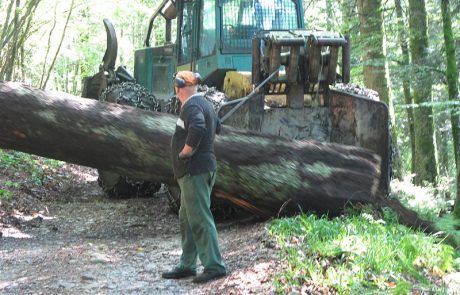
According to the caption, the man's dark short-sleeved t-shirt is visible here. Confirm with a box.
[171,93,220,179]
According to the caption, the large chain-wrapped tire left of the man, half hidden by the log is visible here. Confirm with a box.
[98,82,161,199]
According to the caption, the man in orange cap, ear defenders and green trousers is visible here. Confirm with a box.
[162,71,226,283]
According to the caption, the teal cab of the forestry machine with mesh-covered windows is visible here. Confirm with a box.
[134,0,303,101]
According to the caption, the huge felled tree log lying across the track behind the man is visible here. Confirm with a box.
[0,82,380,216]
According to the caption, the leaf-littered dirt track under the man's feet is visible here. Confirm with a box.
[0,164,282,294]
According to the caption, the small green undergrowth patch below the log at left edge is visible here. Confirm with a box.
[0,149,64,200]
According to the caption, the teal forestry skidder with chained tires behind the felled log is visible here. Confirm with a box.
[83,0,389,214]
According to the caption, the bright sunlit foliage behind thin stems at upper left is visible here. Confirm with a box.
[0,0,157,94]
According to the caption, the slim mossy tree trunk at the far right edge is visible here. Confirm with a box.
[441,0,460,218]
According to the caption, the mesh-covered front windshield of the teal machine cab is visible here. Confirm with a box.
[221,0,300,52]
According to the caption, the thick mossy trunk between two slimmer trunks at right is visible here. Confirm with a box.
[409,0,437,185]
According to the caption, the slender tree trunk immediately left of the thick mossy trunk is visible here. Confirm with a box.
[395,0,415,173]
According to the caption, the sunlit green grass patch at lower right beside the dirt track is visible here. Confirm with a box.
[267,211,458,294]
